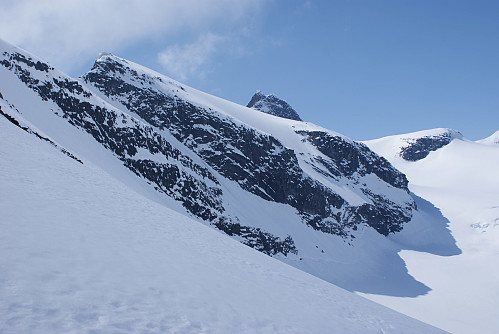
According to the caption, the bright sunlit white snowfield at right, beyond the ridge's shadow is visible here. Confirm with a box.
[366,129,499,334]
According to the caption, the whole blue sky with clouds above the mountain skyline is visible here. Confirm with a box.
[0,0,499,140]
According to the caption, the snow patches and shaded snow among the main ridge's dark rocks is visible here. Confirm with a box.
[0,37,460,297]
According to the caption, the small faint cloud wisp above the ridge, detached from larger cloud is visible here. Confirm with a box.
[158,33,227,81]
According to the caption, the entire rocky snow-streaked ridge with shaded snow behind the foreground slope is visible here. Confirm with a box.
[0,38,460,332]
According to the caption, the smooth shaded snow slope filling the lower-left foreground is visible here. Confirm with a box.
[0,110,450,333]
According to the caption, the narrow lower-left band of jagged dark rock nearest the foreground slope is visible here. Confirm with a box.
[0,48,296,255]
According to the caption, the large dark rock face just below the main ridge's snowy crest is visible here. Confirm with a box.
[84,57,413,237]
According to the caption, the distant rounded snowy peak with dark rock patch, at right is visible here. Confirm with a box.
[366,128,464,162]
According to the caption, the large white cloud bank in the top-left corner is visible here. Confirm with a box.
[0,0,265,70]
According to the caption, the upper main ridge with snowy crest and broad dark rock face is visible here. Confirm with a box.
[83,55,414,240]
